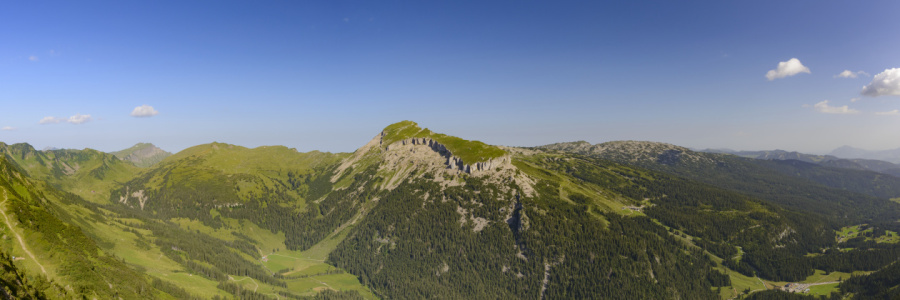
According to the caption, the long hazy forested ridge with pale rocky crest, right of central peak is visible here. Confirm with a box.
[537,141,900,222]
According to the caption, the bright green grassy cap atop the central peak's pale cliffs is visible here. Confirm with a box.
[382,121,506,164]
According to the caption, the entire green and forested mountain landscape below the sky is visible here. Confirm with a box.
[0,121,900,299]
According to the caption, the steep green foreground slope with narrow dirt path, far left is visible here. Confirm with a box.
[0,157,183,299]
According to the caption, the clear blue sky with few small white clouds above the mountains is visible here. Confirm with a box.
[0,0,900,153]
